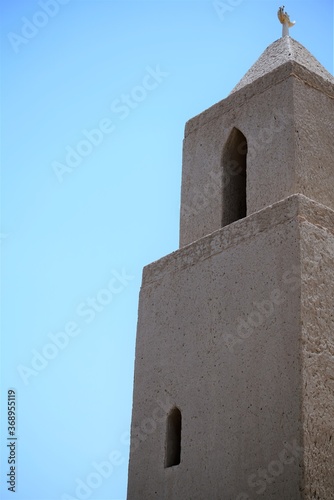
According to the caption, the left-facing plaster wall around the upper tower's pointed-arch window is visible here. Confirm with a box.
[180,71,294,246]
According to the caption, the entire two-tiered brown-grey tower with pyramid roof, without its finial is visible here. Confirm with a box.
[128,36,334,500]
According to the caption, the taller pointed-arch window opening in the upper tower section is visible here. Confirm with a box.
[222,128,247,227]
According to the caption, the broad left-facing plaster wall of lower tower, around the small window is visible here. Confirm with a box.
[128,195,334,500]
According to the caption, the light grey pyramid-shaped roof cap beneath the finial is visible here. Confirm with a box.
[231,36,334,93]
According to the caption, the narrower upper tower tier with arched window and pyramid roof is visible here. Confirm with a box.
[180,36,334,246]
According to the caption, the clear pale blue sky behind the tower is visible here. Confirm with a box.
[0,0,333,500]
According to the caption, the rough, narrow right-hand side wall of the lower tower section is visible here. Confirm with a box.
[301,214,334,500]
